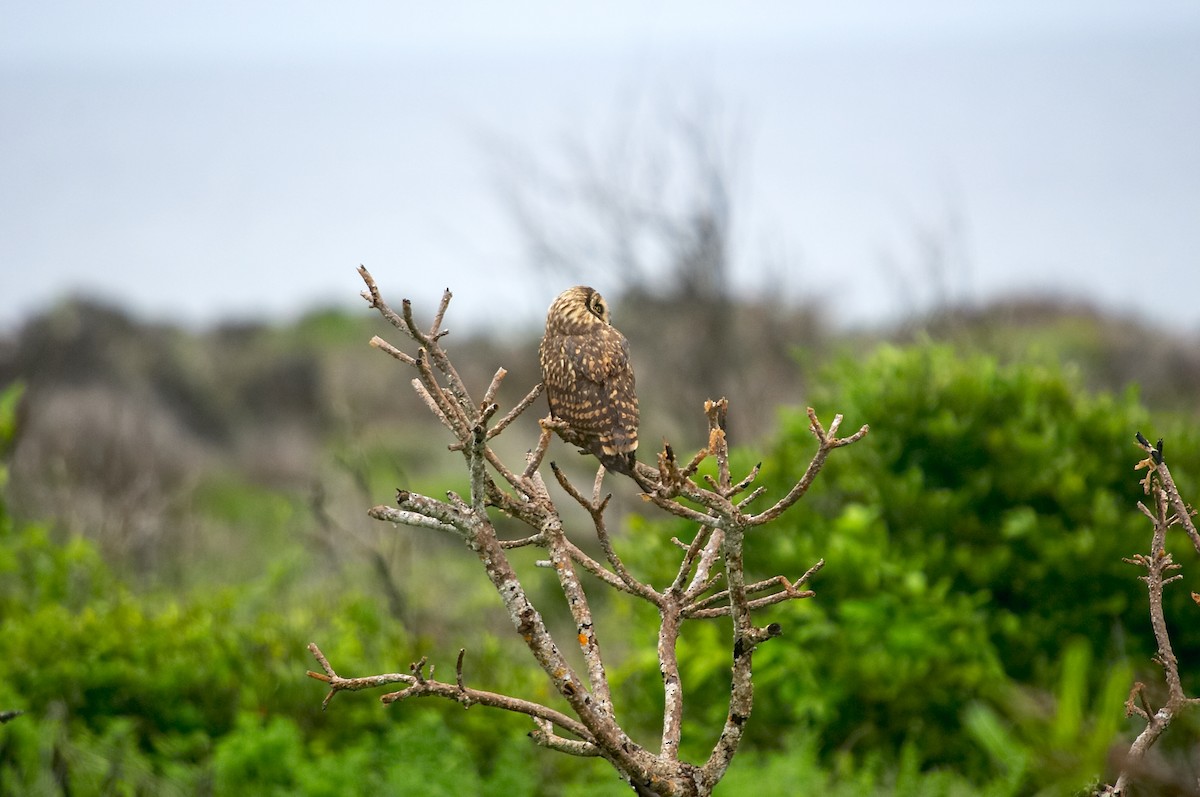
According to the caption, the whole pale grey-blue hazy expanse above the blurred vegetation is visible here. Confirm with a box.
[0,0,1200,331]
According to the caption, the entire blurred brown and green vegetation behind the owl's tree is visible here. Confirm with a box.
[0,279,1200,797]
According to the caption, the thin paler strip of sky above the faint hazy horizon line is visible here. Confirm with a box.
[9,0,1200,62]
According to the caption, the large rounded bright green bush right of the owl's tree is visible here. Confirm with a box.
[614,346,1200,791]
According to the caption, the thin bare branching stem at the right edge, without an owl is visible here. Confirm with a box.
[1099,432,1200,797]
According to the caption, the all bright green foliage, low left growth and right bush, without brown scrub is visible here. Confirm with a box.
[0,340,1200,797]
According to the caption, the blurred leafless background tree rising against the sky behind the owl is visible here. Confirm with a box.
[493,94,748,409]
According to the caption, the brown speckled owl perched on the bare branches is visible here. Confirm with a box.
[538,286,646,489]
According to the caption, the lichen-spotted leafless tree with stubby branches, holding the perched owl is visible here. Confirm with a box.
[308,269,868,797]
